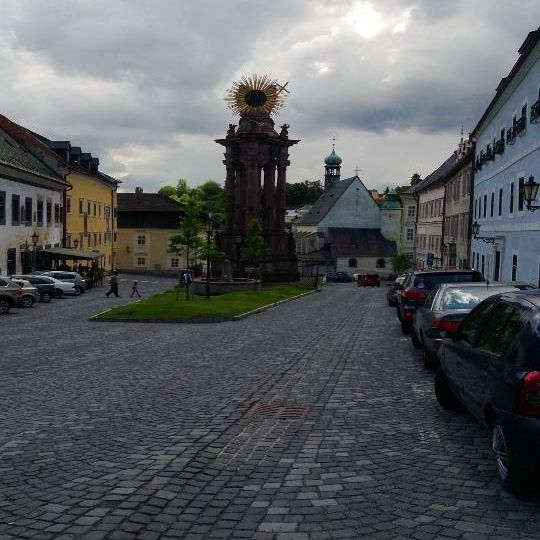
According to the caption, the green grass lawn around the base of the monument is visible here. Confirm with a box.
[92,283,312,321]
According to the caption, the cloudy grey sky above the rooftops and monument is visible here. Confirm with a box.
[0,0,540,191]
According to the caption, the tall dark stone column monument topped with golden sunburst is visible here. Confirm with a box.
[216,75,300,281]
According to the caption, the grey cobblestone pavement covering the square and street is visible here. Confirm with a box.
[0,280,540,540]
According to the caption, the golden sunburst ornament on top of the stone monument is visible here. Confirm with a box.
[225,75,288,115]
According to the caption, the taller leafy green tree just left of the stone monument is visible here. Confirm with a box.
[167,193,203,268]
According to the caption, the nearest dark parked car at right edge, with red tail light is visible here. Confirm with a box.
[429,289,540,490]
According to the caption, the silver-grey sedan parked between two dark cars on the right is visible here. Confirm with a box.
[411,283,518,369]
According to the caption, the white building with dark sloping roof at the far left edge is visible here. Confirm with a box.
[0,115,67,275]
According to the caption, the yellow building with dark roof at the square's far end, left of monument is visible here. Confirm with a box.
[116,188,186,274]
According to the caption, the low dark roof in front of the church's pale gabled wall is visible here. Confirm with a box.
[328,227,397,259]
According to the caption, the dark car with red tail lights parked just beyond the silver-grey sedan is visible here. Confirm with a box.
[396,269,486,334]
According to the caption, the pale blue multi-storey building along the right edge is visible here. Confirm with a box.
[471,29,540,285]
